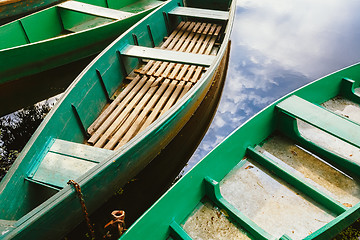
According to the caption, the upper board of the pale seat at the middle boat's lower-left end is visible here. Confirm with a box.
[49,139,113,163]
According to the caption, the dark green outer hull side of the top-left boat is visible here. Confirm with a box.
[0,7,153,85]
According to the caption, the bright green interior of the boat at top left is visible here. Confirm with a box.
[0,0,164,50]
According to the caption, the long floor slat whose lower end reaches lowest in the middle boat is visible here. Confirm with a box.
[115,78,170,150]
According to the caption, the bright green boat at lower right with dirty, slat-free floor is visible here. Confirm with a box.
[120,64,360,240]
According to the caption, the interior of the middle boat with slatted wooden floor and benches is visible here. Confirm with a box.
[0,1,233,225]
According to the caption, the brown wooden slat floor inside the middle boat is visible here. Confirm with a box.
[88,22,221,150]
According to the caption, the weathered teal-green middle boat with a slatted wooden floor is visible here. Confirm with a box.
[0,0,235,239]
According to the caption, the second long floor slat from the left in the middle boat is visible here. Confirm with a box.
[88,77,147,144]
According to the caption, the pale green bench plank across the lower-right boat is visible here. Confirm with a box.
[277,95,360,147]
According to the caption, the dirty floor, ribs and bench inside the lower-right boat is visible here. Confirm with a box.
[170,78,360,239]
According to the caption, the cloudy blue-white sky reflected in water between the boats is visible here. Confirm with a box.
[183,0,360,172]
